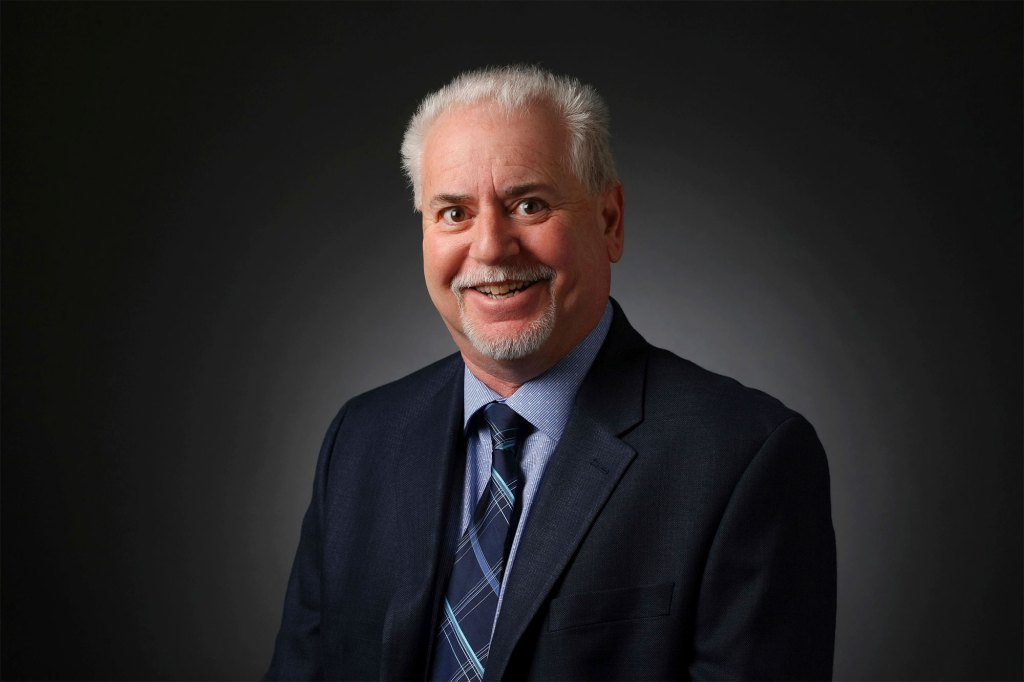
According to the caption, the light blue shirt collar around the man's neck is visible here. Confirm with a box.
[463,301,611,442]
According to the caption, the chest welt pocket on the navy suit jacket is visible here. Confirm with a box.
[548,583,676,631]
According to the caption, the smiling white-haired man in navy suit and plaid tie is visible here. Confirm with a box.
[267,67,836,680]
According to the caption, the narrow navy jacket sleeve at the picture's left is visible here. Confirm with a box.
[263,408,345,680]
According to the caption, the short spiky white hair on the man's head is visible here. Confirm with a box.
[401,65,618,211]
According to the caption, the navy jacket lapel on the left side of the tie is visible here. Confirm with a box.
[381,356,465,679]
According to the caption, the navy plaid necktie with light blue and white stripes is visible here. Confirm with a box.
[431,402,528,681]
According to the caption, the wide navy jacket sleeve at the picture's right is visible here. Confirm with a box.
[689,416,836,680]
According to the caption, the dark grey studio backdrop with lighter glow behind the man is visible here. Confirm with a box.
[0,2,1024,679]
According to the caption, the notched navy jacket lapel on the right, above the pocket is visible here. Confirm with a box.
[484,305,646,680]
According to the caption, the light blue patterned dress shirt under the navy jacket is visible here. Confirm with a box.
[459,302,611,623]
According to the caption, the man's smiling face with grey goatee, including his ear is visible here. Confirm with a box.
[421,103,623,371]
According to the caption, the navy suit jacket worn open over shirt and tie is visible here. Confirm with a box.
[267,305,836,680]
